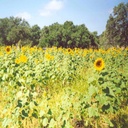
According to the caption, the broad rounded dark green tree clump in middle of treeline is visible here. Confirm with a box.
[39,21,97,48]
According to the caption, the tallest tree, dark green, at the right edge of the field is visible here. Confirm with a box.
[106,3,128,47]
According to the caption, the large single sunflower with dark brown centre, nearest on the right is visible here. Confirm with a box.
[94,58,105,71]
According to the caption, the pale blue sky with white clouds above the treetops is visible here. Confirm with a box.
[0,0,127,34]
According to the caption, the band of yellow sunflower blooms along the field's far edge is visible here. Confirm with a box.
[3,46,123,70]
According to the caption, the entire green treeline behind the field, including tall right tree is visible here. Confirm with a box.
[0,3,128,48]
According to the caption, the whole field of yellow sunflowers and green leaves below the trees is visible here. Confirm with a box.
[0,46,128,128]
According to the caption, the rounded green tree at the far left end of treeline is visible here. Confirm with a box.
[0,17,30,45]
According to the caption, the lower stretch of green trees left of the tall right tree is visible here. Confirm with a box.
[0,17,99,48]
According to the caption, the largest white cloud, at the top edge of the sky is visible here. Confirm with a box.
[40,0,64,16]
